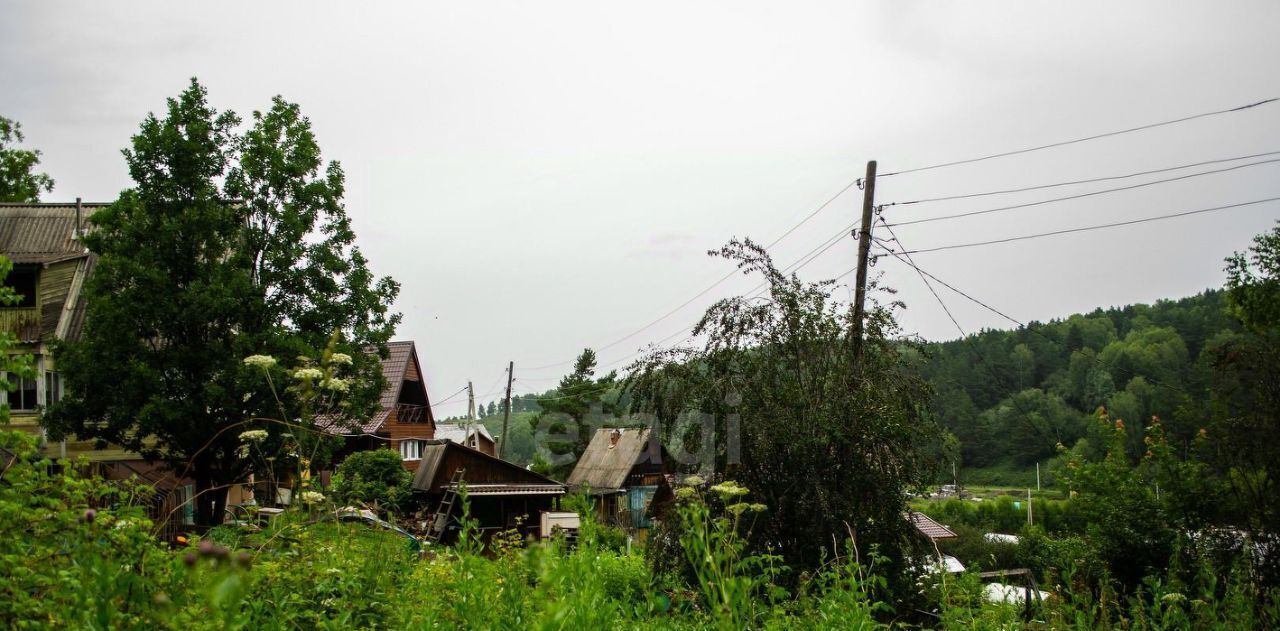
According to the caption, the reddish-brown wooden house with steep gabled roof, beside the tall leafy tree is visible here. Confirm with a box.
[317,342,435,471]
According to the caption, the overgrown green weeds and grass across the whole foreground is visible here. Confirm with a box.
[0,433,1280,631]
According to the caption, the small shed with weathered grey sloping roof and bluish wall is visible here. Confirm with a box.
[566,427,667,531]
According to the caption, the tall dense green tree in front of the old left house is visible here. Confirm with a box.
[46,79,399,523]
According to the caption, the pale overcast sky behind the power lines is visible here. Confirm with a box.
[0,0,1280,416]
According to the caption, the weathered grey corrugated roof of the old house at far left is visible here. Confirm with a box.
[0,202,106,262]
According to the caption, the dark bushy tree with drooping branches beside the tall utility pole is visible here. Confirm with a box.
[630,241,941,578]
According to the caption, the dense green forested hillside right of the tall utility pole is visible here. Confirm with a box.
[924,291,1240,471]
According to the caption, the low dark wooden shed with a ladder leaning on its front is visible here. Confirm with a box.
[413,440,564,536]
